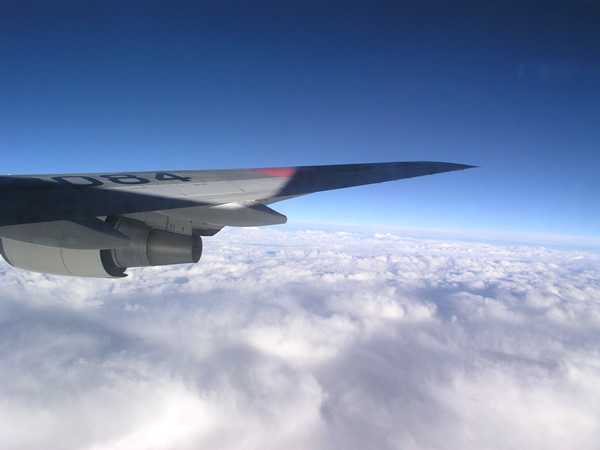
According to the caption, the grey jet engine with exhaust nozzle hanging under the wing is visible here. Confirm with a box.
[0,220,202,278]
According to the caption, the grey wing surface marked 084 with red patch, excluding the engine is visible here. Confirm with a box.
[0,162,473,229]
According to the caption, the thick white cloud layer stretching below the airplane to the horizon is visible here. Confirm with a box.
[0,229,600,449]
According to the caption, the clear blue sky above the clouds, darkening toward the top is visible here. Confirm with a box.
[0,1,600,236]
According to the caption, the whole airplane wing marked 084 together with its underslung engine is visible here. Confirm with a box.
[0,162,474,277]
